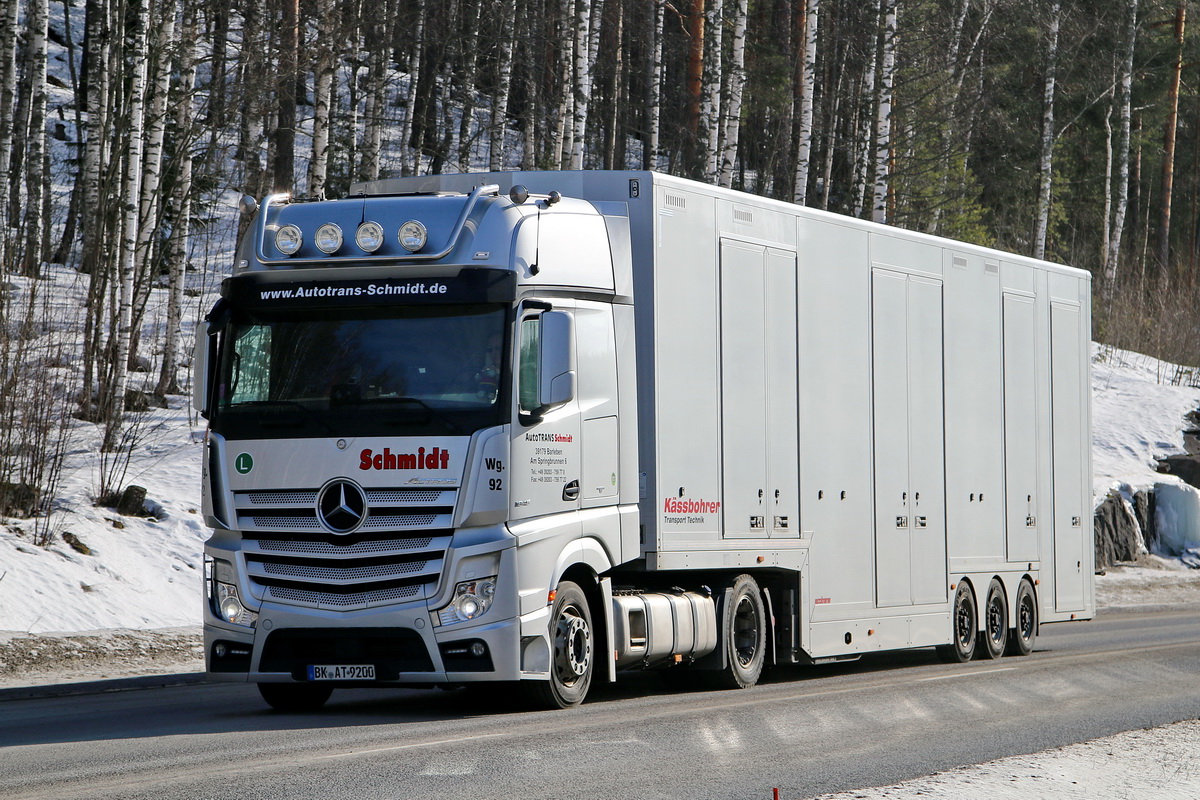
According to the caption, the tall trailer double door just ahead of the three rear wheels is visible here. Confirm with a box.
[871,269,947,607]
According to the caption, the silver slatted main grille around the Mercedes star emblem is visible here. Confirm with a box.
[234,488,457,610]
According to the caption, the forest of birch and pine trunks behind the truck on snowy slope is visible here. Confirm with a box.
[0,0,1200,539]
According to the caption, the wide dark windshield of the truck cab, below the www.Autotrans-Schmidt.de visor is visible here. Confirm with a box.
[212,305,506,439]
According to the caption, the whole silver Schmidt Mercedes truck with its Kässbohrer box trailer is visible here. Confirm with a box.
[194,172,1094,709]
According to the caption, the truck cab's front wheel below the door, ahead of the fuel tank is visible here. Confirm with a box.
[523,581,596,709]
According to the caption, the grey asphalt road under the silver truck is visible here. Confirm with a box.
[0,612,1200,800]
